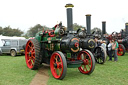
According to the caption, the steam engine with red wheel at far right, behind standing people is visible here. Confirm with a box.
[103,23,128,56]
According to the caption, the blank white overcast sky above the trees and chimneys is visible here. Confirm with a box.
[0,0,128,33]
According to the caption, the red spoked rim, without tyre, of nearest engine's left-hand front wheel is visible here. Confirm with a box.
[50,53,63,79]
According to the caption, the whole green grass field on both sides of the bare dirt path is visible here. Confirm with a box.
[0,54,128,85]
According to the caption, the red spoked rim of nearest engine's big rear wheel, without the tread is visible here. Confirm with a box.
[25,40,35,69]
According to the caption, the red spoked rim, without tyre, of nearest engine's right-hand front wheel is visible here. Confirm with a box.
[78,51,92,74]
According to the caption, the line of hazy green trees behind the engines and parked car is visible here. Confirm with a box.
[0,23,101,38]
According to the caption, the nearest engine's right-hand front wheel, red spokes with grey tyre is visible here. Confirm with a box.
[77,50,95,74]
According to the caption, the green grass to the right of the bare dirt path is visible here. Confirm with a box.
[47,54,128,85]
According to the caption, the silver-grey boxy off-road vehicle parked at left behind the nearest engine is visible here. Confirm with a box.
[0,39,27,56]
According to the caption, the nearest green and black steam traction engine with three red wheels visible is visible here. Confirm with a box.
[25,4,95,79]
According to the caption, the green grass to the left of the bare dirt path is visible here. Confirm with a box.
[0,56,37,85]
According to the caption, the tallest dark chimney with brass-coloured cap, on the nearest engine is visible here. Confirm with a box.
[65,4,74,32]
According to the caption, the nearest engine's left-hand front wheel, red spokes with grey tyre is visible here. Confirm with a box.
[50,51,67,79]
